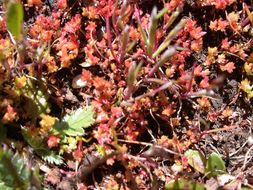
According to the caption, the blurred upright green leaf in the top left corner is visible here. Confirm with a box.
[7,3,24,39]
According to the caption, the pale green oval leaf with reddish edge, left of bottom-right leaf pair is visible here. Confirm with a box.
[185,149,206,173]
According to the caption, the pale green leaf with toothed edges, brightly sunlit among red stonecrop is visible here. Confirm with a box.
[53,107,95,136]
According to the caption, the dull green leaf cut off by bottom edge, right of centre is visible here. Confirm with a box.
[165,179,205,190]
